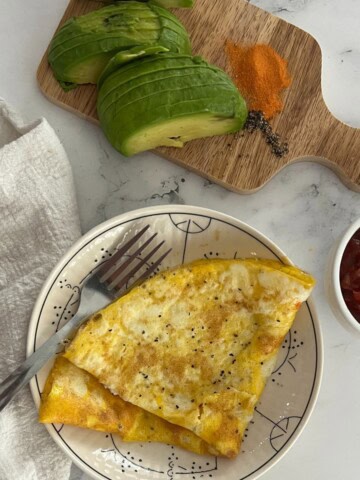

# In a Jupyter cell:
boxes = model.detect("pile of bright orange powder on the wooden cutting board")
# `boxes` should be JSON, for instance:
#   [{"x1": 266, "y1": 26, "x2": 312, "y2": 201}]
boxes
[{"x1": 225, "y1": 40, "x2": 291, "y2": 119}]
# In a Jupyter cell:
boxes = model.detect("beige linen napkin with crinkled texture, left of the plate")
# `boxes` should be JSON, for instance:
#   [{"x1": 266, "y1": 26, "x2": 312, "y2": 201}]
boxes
[{"x1": 0, "y1": 98, "x2": 80, "y2": 480}]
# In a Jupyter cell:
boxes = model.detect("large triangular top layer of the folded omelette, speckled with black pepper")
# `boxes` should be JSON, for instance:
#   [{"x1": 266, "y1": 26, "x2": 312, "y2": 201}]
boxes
[{"x1": 60, "y1": 259, "x2": 314, "y2": 458}]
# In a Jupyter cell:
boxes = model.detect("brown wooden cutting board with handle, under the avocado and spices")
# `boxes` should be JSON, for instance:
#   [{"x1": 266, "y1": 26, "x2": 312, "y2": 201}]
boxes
[{"x1": 37, "y1": 0, "x2": 360, "y2": 193}]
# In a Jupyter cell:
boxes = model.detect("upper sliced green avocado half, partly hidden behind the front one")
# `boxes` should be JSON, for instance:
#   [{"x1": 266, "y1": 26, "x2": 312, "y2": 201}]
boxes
[{"x1": 48, "y1": 1, "x2": 191, "y2": 84}]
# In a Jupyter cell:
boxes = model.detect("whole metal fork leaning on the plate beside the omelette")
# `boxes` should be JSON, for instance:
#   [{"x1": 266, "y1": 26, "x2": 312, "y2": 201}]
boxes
[{"x1": 0, "y1": 225, "x2": 171, "y2": 411}]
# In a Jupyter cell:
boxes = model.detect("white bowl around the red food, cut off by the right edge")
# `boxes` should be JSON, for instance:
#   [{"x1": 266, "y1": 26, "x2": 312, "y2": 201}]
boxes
[{"x1": 325, "y1": 218, "x2": 360, "y2": 335}]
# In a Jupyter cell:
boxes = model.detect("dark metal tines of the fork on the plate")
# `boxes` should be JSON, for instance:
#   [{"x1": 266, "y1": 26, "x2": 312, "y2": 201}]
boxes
[{"x1": 98, "y1": 225, "x2": 171, "y2": 290}]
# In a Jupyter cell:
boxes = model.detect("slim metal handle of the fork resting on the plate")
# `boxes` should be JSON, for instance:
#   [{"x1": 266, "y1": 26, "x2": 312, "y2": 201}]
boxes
[{"x1": 0, "y1": 315, "x2": 86, "y2": 412}]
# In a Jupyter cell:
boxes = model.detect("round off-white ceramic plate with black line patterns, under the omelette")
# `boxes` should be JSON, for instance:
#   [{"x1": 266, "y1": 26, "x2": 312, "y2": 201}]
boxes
[{"x1": 27, "y1": 206, "x2": 323, "y2": 480}]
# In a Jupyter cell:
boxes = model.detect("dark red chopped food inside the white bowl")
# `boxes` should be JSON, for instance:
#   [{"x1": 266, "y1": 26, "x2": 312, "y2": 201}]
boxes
[{"x1": 340, "y1": 229, "x2": 360, "y2": 322}]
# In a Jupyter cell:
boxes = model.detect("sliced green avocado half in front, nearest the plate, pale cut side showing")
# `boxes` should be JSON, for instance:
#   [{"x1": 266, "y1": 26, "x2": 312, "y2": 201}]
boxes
[{"x1": 97, "y1": 53, "x2": 247, "y2": 156}]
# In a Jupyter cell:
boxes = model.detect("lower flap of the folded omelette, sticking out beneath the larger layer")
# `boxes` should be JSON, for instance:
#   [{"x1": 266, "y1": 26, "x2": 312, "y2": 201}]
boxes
[{"x1": 39, "y1": 356, "x2": 216, "y2": 454}]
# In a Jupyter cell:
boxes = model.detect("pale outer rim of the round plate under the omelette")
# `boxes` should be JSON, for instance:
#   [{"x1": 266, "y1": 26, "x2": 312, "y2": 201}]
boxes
[{"x1": 26, "y1": 204, "x2": 324, "y2": 480}]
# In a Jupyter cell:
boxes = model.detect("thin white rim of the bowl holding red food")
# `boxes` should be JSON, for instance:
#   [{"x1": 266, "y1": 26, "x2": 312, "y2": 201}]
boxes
[{"x1": 332, "y1": 218, "x2": 360, "y2": 333}]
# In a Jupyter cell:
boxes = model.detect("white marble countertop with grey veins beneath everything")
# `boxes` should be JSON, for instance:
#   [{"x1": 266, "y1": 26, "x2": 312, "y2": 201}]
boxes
[{"x1": 0, "y1": 0, "x2": 360, "y2": 480}]
